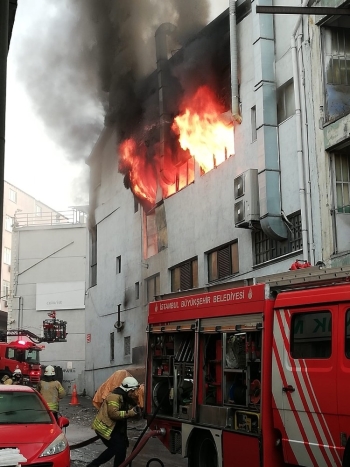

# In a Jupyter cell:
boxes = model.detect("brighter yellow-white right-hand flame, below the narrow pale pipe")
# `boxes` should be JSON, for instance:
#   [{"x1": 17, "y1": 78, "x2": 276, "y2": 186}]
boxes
[{"x1": 172, "y1": 86, "x2": 234, "y2": 172}]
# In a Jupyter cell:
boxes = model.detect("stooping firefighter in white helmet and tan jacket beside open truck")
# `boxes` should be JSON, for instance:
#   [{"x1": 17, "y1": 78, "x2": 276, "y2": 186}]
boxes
[{"x1": 86, "y1": 376, "x2": 141, "y2": 467}]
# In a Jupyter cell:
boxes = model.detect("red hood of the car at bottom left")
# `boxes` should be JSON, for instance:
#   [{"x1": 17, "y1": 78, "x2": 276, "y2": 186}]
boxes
[{"x1": 0, "y1": 424, "x2": 62, "y2": 462}]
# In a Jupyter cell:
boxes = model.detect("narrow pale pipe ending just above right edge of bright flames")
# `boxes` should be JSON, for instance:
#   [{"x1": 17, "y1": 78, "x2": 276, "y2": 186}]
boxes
[{"x1": 229, "y1": 0, "x2": 242, "y2": 123}]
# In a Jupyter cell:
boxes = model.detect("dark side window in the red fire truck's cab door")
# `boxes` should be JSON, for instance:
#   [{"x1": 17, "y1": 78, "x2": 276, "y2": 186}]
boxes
[{"x1": 290, "y1": 311, "x2": 332, "y2": 359}]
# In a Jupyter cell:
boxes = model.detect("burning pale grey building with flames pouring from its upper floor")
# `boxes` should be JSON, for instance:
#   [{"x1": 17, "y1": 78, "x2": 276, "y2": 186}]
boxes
[{"x1": 86, "y1": 0, "x2": 350, "y2": 394}]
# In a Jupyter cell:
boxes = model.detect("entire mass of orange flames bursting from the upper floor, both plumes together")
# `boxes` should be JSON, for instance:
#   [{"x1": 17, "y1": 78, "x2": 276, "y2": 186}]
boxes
[{"x1": 119, "y1": 86, "x2": 234, "y2": 206}]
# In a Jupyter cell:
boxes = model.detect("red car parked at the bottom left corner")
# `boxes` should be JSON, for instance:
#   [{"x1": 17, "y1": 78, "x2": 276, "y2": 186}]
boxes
[{"x1": 0, "y1": 385, "x2": 70, "y2": 467}]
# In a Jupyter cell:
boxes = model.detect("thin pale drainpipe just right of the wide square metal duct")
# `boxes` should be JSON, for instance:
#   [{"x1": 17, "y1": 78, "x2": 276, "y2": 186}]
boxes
[{"x1": 291, "y1": 0, "x2": 315, "y2": 263}]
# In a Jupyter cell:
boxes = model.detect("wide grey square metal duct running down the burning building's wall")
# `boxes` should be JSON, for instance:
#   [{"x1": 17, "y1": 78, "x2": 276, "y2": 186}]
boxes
[{"x1": 252, "y1": 0, "x2": 287, "y2": 240}]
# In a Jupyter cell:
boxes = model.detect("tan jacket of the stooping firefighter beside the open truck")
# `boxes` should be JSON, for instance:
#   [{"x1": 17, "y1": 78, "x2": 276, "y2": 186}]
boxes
[{"x1": 91, "y1": 388, "x2": 137, "y2": 439}]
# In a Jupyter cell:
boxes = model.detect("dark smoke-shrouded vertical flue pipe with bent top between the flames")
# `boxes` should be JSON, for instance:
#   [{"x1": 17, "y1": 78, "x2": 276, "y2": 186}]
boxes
[{"x1": 155, "y1": 23, "x2": 176, "y2": 202}]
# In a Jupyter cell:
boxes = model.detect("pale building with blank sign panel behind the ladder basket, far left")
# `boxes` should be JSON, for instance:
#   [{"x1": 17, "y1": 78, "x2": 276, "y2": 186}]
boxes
[{"x1": 8, "y1": 210, "x2": 87, "y2": 392}]
